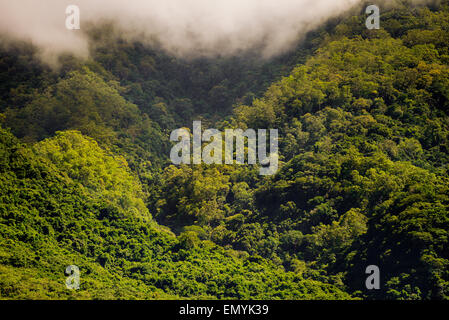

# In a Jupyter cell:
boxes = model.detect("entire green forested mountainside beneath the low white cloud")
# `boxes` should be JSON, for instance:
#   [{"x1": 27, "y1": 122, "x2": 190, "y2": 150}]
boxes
[{"x1": 0, "y1": 1, "x2": 449, "y2": 299}]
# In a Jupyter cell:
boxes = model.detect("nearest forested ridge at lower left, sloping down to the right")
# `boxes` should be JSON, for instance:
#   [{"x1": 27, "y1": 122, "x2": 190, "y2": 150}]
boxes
[{"x1": 0, "y1": 129, "x2": 349, "y2": 299}]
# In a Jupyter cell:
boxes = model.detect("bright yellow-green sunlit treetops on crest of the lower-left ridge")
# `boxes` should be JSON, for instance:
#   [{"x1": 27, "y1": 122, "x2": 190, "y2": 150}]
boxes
[{"x1": 34, "y1": 131, "x2": 151, "y2": 219}]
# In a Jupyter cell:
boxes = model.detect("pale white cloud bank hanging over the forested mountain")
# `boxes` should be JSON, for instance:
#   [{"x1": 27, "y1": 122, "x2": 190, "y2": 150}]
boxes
[{"x1": 0, "y1": 0, "x2": 432, "y2": 63}]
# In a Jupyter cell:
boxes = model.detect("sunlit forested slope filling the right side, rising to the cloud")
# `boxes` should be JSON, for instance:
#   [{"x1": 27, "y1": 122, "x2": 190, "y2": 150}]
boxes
[{"x1": 152, "y1": 1, "x2": 449, "y2": 299}]
